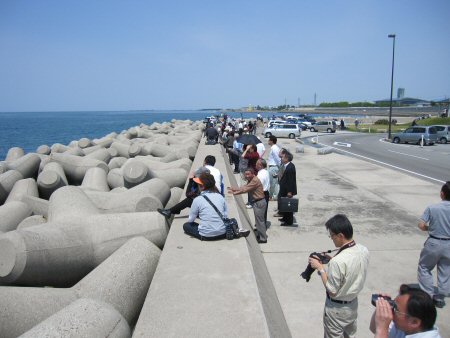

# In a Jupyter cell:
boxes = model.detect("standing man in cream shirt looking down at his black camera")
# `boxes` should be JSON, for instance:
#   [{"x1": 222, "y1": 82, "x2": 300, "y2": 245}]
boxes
[{"x1": 309, "y1": 214, "x2": 369, "y2": 338}]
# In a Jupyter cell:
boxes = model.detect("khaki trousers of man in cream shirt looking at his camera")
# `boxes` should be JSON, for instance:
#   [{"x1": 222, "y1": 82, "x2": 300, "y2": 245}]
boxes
[{"x1": 323, "y1": 298, "x2": 358, "y2": 338}]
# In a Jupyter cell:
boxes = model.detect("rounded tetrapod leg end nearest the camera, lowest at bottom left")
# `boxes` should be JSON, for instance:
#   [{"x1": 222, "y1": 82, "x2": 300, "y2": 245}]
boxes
[{"x1": 20, "y1": 299, "x2": 131, "y2": 338}]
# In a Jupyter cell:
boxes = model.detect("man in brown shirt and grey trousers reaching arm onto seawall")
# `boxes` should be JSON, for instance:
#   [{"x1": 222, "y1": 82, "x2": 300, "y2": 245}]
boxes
[{"x1": 228, "y1": 168, "x2": 267, "y2": 243}]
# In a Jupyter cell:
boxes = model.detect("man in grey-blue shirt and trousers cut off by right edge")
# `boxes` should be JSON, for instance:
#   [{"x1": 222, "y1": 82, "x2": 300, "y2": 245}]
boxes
[{"x1": 417, "y1": 181, "x2": 450, "y2": 308}]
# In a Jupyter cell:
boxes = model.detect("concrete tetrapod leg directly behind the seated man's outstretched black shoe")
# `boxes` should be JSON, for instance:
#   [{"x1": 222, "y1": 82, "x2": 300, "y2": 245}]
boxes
[{"x1": 85, "y1": 178, "x2": 171, "y2": 213}]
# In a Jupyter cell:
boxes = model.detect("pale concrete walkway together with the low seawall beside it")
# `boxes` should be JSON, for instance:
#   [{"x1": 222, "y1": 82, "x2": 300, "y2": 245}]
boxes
[{"x1": 134, "y1": 132, "x2": 450, "y2": 338}]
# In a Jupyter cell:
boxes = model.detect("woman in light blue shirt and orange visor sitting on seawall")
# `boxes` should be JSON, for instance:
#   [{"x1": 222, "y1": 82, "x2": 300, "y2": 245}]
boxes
[{"x1": 183, "y1": 173, "x2": 228, "y2": 241}]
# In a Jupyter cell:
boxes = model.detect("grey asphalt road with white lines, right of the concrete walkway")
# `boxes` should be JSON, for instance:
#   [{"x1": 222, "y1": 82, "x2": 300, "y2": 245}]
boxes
[{"x1": 302, "y1": 131, "x2": 450, "y2": 183}]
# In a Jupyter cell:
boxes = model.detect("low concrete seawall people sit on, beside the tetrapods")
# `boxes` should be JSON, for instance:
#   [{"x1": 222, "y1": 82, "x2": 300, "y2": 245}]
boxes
[{"x1": 133, "y1": 142, "x2": 291, "y2": 337}]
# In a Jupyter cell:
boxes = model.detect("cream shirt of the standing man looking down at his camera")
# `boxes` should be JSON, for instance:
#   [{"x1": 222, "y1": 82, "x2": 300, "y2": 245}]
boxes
[{"x1": 326, "y1": 244, "x2": 369, "y2": 302}]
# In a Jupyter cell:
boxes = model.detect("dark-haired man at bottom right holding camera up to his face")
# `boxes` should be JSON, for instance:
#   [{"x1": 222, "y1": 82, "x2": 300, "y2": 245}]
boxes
[{"x1": 370, "y1": 284, "x2": 441, "y2": 338}]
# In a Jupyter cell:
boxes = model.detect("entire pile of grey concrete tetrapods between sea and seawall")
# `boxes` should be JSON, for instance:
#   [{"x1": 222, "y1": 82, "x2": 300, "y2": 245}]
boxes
[{"x1": 0, "y1": 120, "x2": 203, "y2": 337}]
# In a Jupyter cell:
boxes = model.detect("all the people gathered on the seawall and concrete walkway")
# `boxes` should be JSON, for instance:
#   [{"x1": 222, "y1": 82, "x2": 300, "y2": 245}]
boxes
[{"x1": 158, "y1": 120, "x2": 450, "y2": 338}]
